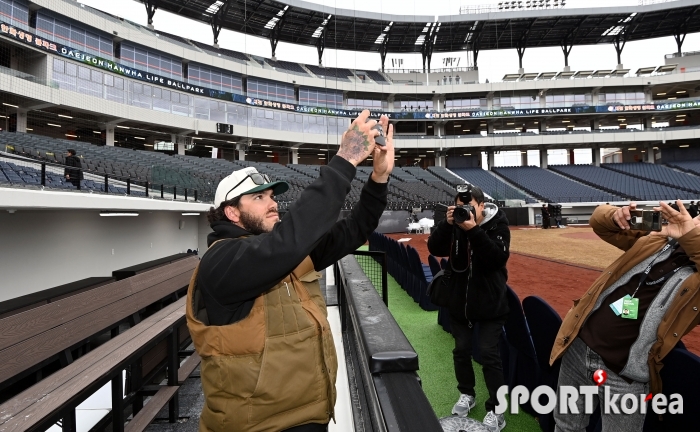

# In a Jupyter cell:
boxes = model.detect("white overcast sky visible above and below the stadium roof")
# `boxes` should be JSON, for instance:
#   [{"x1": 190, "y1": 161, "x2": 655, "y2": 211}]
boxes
[{"x1": 79, "y1": 0, "x2": 700, "y2": 82}]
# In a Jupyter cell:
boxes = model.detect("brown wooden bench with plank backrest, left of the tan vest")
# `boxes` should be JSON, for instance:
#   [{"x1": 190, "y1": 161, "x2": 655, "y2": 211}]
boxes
[{"x1": 0, "y1": 255, "x2": 199, "y2": 432}]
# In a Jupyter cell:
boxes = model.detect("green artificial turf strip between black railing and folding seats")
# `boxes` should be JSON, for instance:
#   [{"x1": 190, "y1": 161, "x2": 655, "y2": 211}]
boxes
[{"x1": 360, "y1": 246, "x2": 541, "y2": 432}]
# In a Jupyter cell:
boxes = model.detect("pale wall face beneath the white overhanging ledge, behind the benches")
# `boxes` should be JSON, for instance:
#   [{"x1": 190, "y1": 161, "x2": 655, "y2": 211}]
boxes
[{"x1": 0, "y1": 210, "x2": 205, "y2": 301}]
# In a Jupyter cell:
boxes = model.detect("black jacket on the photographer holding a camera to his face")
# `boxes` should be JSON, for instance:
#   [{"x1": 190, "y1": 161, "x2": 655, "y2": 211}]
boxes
[{"x1": 428, "y1": 208, "x2": 510, "y2": 322}]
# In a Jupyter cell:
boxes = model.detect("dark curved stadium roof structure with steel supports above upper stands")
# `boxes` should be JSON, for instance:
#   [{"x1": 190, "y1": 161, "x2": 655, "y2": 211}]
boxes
[{"x1": 140, "y1": 0, "x2": 700, "y2": 69}]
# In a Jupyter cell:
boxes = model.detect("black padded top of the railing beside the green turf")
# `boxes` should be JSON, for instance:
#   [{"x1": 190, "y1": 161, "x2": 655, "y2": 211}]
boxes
[{"x1": 341, "y1": 255, "x2": 418, "y2": 374}]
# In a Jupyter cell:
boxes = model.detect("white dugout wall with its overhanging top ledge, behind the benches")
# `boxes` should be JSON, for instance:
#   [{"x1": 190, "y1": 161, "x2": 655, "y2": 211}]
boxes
[{"x1": 0, "y1": 188, "x2": 210, "y2": 301}]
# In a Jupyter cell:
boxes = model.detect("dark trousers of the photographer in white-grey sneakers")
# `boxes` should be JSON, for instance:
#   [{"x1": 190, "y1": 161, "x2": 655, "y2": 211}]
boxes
[{"x1": 450, "y1": 316, "x2": 505, "y2": 412}]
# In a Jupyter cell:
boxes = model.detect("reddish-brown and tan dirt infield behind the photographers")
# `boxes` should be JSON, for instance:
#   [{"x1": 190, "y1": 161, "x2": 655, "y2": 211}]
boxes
[{"x1": 382, "y1": 227, "x2": 700, "y2": 354}]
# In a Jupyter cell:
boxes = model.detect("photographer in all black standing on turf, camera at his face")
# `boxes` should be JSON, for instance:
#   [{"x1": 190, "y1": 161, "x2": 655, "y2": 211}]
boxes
[{"x1": 428, "y1": 185, "x2": 510, "y2": 432}]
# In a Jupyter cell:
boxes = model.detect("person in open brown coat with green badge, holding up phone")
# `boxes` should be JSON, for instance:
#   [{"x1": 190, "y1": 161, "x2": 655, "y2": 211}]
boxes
[{"x1": 549, "y1": 200, "x2": 700, "y2": 432}]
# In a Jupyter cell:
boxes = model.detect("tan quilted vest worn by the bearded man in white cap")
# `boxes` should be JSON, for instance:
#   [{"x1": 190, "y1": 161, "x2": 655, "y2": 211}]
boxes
[{"x1": 187, "y1": 253, "x2": 338, "y2": 432}]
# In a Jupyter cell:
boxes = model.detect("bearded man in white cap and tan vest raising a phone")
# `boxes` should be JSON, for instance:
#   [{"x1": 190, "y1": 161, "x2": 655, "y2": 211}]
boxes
[{"x1": 187, "y1": 110, "x2": 394, "y2": 432}]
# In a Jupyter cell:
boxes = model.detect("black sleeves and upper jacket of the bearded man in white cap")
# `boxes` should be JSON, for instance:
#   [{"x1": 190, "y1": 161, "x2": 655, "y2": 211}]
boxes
[{"x1": 197, "y1": 157, "x2": 387, "y2": 325}]
